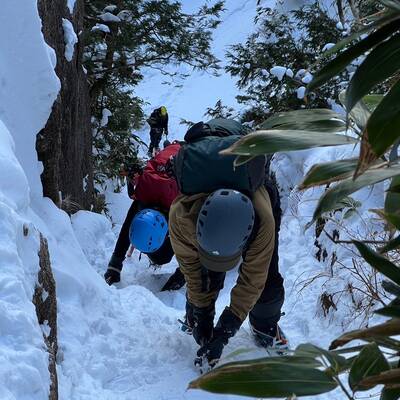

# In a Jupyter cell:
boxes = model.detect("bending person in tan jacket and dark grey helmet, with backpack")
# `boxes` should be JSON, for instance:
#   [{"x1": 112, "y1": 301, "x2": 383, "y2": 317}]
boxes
[{"x1": 169, "y1": 119, "x2": 287, "y2": 367}]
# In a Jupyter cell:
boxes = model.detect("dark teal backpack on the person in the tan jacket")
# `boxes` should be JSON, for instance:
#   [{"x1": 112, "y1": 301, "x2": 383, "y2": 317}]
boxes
[{"x1": 173, "y1": 118, "x2": 266, "y2": 195}]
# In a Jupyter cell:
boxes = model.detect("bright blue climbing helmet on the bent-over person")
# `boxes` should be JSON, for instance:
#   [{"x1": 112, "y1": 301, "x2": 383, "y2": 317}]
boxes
[{"x1": 129, "y1": 208, "x2": 168, "y2": 253}]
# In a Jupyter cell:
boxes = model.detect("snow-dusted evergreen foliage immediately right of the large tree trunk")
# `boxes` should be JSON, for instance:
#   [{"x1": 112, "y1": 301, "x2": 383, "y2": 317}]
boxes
[{"x1": 82, "y1": 0, "x2": 223, "y2": 183}]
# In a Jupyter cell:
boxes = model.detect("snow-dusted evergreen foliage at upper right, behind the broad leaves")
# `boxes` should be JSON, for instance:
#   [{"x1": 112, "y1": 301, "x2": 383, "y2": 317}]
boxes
[{"x1": 226, "y1": 1, "x2": 348, "y2": 123}]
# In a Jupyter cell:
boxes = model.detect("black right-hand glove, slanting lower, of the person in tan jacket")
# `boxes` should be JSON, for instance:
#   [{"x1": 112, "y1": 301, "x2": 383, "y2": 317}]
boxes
[{"x1": 197, "y1": 308, "x2": 242, "y2": 368}]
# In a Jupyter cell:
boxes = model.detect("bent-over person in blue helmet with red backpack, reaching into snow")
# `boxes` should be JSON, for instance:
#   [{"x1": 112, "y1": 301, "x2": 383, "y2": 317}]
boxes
[{"x1": 104, "y1": 143, "x2": 185, "y2": 291}]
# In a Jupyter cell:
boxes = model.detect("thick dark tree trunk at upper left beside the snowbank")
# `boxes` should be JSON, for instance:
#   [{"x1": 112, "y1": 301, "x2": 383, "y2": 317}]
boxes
[{"x1": 36, "y1": 0, "x2": 93, "y2": 212}]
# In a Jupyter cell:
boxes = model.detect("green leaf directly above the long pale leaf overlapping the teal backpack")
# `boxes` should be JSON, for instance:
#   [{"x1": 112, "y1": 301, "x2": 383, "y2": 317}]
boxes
[{"x1": 257, "y1": 108, "x2": 346, "y2": 130}]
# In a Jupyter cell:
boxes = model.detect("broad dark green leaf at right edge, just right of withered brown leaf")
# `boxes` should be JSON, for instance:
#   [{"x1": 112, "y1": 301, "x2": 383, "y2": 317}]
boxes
[{"x1": 366, "y1": 80, "x2": 400, "y2": 157}]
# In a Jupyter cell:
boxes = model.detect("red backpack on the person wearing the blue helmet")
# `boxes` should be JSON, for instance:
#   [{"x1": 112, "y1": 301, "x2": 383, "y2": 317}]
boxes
[{"x1": 135, "y1": 143, "x2": 181, "y2": 211}]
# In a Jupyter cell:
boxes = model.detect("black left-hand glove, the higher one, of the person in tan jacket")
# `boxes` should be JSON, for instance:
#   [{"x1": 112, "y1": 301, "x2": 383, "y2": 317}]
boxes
[{"x1": 186, "y1": 301, "x2": 215, "y2": 346}]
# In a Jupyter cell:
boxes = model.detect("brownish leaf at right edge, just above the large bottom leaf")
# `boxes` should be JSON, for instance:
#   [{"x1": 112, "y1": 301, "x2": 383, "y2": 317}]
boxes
[{"x1": 329, "y1": 319, "x2": 400, "y2": 350}]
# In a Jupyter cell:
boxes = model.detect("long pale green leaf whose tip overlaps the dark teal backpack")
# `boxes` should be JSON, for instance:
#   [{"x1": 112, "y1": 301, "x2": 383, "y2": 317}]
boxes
[{"x1": 221, "y1": 130, "x2": 355, "y2": 161}]
